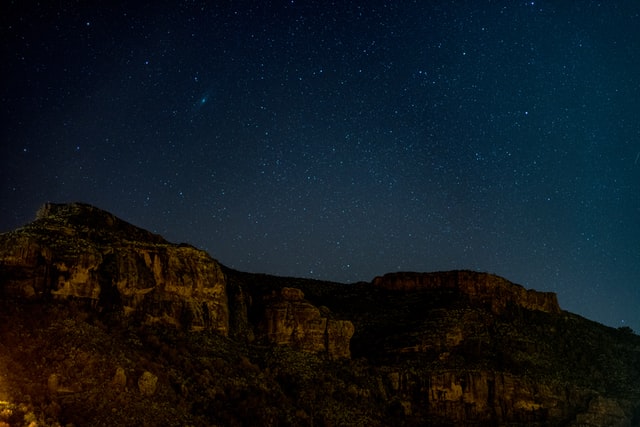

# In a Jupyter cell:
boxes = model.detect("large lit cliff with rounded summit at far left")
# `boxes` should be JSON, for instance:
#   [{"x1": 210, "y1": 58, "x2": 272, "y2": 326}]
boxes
[{"x1": 0, "y1": 203, "x2": 229, "y2": 335}]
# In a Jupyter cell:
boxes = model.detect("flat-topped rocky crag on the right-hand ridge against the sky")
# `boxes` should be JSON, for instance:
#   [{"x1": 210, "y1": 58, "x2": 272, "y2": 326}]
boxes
[{"x1": 372, "y1": 271, "x2": 560, "y2": 313}]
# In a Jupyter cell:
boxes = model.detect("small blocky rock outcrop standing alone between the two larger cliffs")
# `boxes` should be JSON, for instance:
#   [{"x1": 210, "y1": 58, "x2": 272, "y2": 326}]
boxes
[{"x1": 264, "y1": 288, "x2": 354, "y2": 358}]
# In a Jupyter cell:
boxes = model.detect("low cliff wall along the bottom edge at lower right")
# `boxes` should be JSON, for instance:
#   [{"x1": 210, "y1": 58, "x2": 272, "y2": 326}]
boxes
[{"x1": 386, "y1": 370, "x2": 596, "y2": 425}]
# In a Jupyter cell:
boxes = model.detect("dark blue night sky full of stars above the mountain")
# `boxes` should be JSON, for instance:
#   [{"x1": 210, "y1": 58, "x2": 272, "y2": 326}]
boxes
[{"x1": 0, "y1": 0, "x2": 640, "y2": 333}]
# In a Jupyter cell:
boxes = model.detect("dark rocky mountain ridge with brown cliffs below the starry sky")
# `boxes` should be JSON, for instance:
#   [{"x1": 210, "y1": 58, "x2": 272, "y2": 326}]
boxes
[{"x1": 0, "y1": 203, "x2": 640, "y2": 427}]
